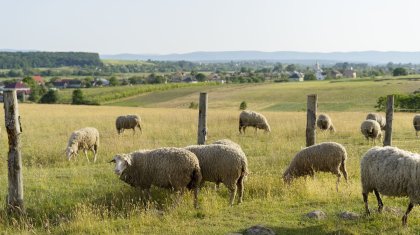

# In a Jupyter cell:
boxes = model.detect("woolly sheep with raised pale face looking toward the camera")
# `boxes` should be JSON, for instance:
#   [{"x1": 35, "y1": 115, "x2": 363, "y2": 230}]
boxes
[{"x1": 110, "y1": 147, "x2": 202, "y2": 208}]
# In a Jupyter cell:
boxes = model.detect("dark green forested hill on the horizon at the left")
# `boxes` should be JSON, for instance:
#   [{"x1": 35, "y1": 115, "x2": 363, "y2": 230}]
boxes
[{"x1": 0, "y1": 51, "x2": 102, "y2": 69}]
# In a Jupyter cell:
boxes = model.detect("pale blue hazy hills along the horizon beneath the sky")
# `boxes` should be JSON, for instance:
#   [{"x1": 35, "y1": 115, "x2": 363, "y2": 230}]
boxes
[{"x1": 101, "y1": 51, "x2": 420, "y2": 64}]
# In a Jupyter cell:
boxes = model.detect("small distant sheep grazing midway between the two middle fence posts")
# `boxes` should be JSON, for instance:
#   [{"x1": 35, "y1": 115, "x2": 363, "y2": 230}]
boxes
[{"x1": 239, "y1": 110, "x2": 271, "y2": 134}]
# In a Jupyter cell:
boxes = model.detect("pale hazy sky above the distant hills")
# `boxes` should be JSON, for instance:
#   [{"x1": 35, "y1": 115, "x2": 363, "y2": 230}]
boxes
[{"x1": 0, "y1": 0, "x2": 420, "y2": 54}]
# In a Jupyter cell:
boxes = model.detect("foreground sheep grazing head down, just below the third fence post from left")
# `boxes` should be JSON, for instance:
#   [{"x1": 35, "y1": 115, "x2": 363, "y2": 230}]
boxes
[{"x1": 283, "y1": 142, "x2": 347, "y2": 191}]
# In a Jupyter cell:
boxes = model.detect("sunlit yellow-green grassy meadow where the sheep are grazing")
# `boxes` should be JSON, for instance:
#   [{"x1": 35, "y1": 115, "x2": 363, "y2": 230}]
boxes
[{"x1": 0, "y1": 80, "x2": 420, "y2": 234}]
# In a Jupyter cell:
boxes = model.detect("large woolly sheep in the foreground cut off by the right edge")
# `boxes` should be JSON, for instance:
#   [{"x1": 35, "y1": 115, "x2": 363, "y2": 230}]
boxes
[{"x1": 360, "y1": 146, "x2": 420, "y2": 226}]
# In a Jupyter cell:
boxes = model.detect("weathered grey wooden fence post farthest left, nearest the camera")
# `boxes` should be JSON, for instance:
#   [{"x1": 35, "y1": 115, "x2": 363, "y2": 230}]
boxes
[{"x1": 3, "y1": 90, "x2": 25, "y2": 214}]
